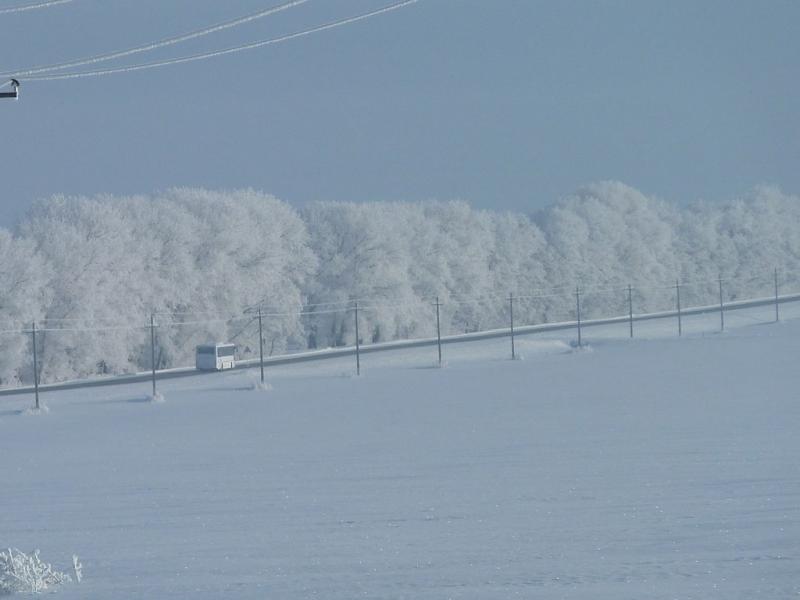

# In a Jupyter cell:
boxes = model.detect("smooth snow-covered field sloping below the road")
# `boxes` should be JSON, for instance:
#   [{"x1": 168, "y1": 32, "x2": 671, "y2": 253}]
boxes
[{"x1": 0, "y1": 306, "x2": 800, "y2": 600}]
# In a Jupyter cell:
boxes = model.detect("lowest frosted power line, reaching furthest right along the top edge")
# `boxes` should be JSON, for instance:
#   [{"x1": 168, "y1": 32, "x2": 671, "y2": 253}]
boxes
[{"x1": 20, "y1": 0, "x2": 418, "y2": 81}]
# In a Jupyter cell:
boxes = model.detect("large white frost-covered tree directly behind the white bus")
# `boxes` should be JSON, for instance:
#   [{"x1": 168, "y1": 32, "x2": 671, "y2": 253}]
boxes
[{"x1": 129, "y1": 189, "x2": 316, "y2": 365}]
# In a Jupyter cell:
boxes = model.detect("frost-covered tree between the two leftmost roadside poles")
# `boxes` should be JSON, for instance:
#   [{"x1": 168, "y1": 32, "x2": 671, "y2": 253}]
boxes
[{"x1": 21, "y1": 196, "x2": 141, "y2": 380}]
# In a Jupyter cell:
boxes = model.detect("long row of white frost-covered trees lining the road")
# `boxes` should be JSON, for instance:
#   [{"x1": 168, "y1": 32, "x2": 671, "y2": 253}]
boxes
[{"x1": 0, "y1": 182, "x2": 800, "y2": 385}]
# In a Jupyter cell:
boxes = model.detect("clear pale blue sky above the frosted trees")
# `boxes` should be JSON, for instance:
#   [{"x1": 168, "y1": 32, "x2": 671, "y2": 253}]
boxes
[{"x1": 0, "y1": 0, "x2": 800, "y2": 225}]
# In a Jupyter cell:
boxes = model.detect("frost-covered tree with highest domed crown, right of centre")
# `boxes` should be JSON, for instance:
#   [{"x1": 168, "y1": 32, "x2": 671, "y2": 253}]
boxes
[{"x1": 538, "y1": 182, "x2": 681, "y2": 320}]
